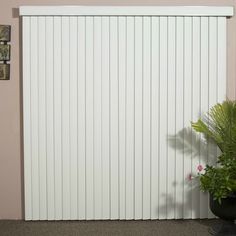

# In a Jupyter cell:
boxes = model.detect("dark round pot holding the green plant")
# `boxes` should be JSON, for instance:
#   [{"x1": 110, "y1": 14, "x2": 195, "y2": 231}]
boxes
[{"x1": 210, "y1": 194, "x2": 236, "y2": 221}]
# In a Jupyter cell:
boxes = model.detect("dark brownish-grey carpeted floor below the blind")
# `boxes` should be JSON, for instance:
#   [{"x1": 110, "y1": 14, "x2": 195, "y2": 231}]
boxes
[{"x1": 0, "y1": 220, "x2": 236, "y2": 236}]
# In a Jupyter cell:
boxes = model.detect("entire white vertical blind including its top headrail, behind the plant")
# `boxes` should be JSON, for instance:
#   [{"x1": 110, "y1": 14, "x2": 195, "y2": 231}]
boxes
[{"x1": 21, "y1": 6, "x2": 232, "y2": 220}]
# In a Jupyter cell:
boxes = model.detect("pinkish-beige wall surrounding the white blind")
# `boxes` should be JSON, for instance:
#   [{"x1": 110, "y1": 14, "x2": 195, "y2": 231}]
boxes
[{"x1": 0, "y1": 0, "x2": 236, "y2": 219}]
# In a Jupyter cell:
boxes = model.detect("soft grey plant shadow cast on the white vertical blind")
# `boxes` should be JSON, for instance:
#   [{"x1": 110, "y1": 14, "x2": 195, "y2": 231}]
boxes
[{"x1": 159, "y1": 127, "x2": 217, "y2": 218}]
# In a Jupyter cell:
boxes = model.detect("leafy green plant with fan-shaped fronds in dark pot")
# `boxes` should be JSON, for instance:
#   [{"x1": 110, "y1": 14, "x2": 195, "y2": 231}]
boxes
[{"x1": 191, "y1": 100, "x2": 236, "y2": 202}]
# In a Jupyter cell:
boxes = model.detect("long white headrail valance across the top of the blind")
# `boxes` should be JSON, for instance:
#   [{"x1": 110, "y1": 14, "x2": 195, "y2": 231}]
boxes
[{"x1": 20, "y1": 6, "x2": 234, "y2": 17}]
